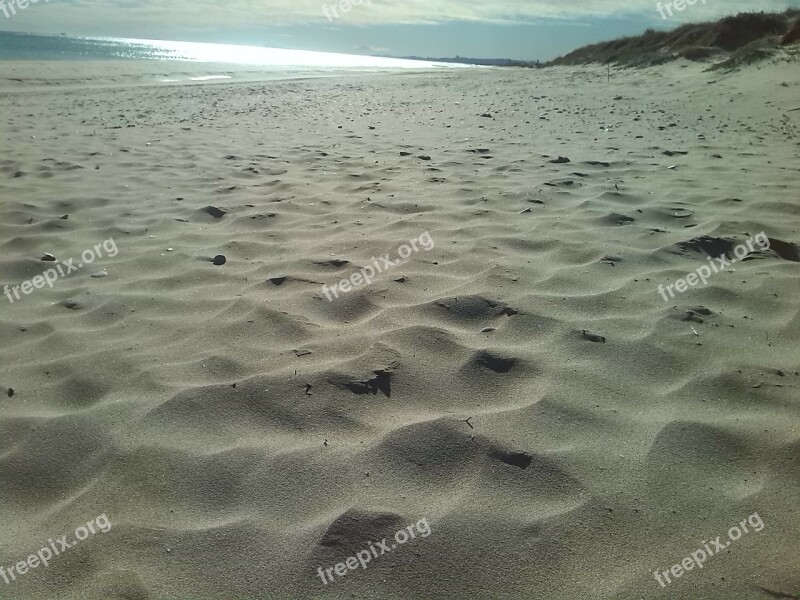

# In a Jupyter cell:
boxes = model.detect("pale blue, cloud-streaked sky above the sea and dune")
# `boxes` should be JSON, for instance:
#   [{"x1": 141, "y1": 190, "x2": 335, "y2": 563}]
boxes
[{"x1": 0, "y1": 0, "x2": 800, "y2": 60}]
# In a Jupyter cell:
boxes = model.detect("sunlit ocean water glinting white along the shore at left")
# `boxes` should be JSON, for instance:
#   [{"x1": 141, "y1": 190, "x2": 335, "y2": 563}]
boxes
[{"x1": 0, "y1": 31, "x2": 450, "y2": 69}]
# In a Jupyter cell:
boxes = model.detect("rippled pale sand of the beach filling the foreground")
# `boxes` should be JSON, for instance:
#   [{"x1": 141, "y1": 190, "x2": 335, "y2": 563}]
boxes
[{"x1": 0, "y1": 57, "x2": 800, "y2": 600}]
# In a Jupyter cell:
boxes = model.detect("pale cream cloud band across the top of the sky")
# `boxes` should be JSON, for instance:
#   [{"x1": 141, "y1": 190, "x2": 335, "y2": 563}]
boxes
[{"x1": 10, "y1": 0, "x2": 800, "y2": 31}]
